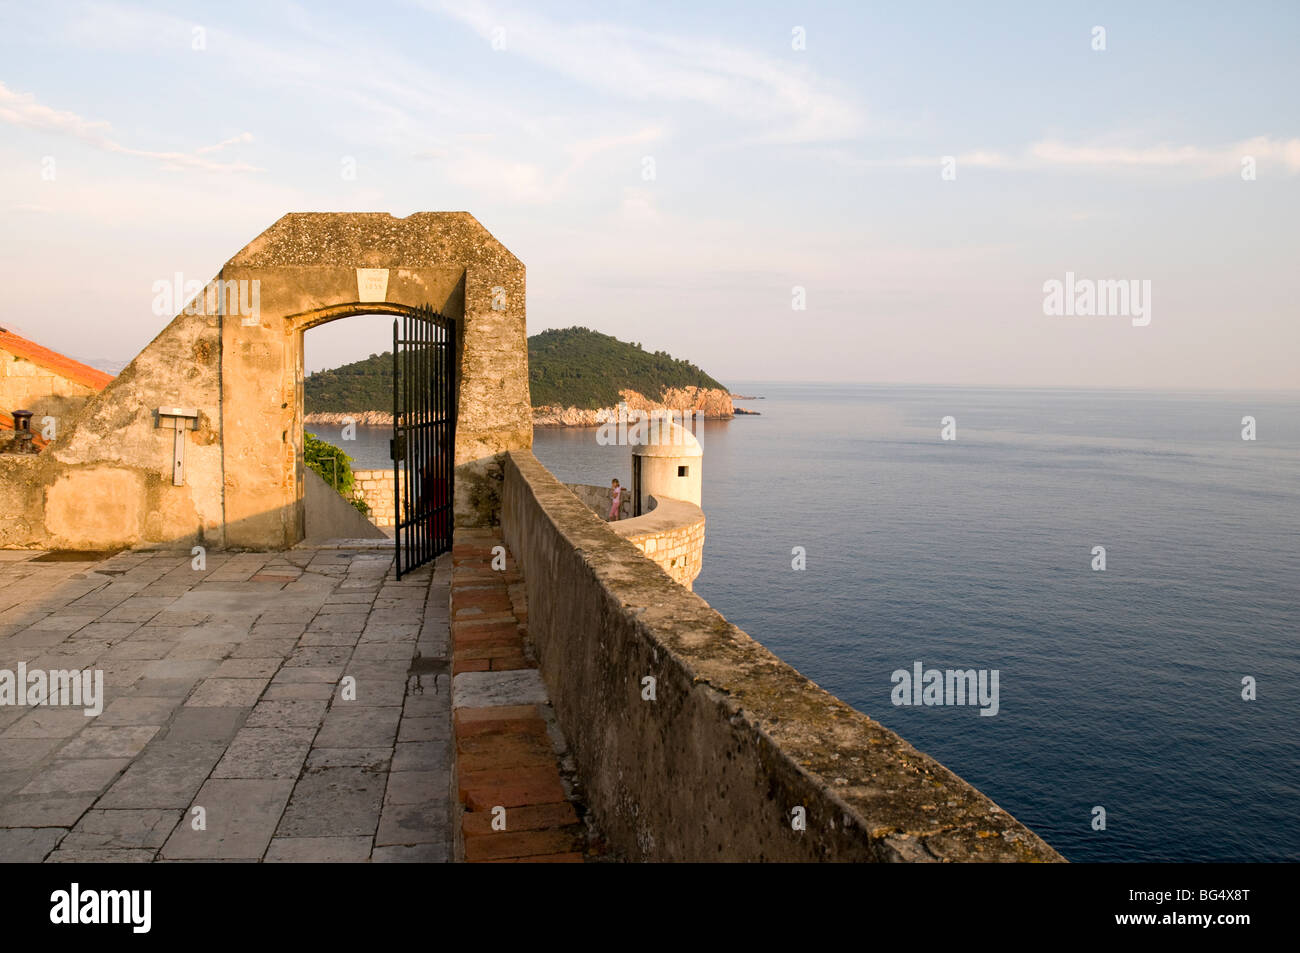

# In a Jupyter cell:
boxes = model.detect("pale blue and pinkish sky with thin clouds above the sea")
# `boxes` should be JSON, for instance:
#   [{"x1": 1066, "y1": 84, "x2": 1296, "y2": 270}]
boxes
[{"x1": 0, "y1": 0, "x2": 1300, "y2": 390}]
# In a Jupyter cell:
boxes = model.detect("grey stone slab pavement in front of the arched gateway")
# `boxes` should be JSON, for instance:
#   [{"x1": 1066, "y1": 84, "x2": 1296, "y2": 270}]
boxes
[{"x1": 0, "y1": 545, "x2": 452, "y2": 862}]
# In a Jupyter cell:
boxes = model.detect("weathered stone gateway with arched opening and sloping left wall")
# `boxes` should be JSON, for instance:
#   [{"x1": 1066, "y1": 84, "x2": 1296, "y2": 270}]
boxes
[{"x1": 0, "y1": 212, "x2": 532, "y2": 550}]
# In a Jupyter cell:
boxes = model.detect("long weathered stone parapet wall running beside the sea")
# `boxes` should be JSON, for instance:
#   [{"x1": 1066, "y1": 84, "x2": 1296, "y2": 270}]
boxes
[{"x1": 502, "y1": 451, "x2": 1063, "y2": 862}]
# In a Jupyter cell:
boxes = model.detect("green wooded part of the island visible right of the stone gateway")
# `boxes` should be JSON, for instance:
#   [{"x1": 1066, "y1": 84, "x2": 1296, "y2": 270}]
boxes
[{"x1": 528, "y1": 328, "x2": 725, "y2": 410}]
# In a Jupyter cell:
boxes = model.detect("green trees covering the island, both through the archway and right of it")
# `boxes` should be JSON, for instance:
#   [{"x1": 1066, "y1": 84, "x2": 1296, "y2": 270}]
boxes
[{"x1": 303, "y1": 328, "x2": 725, "y2": 410}]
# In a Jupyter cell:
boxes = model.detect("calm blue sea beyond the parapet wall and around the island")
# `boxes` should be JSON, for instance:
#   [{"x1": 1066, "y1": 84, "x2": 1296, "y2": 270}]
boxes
[{"x1": 306, "y1": 381, "x2": 1300, "y2": 862}]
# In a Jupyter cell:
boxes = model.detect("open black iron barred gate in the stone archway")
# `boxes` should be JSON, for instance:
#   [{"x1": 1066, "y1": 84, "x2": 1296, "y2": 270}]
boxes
[{"x1": 390, "y1": 306, "x2": 456, "y2": 579}]
